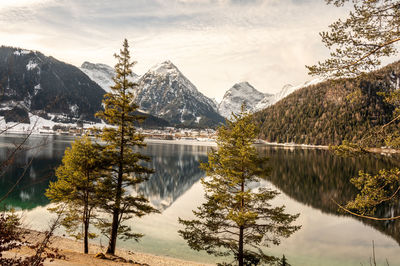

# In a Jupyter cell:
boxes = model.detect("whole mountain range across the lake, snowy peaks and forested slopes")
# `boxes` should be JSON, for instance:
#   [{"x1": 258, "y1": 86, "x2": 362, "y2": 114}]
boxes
[{"x1": 6, "y1": 46, "x2": 400, "y2": 145}]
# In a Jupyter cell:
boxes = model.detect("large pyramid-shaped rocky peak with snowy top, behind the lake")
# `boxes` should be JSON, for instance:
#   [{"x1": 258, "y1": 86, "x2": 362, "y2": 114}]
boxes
[{"x1": 136, "y1": 61, "x2": 224, "y2": 127}]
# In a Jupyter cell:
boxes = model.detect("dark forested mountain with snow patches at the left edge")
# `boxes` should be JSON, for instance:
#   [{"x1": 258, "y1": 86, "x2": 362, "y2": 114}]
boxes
[{"x1": 0, "y1": 46, "x2": 105, "y2": 122}]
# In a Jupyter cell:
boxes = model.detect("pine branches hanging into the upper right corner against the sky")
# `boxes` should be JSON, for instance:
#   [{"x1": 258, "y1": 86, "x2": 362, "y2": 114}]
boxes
[{"x1": 307, "y1": 0, "x2": 400, "y2": 77}]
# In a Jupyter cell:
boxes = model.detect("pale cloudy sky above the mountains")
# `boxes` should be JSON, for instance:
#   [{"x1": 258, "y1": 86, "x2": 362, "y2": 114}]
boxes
[{"x1": 0, "y1": 0, "x2": 354, "y2": 99}]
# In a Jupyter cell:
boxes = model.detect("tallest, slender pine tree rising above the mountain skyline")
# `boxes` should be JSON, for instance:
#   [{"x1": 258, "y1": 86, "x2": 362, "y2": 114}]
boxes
[{"x1": 96, "y1": 39, "x2": 156, "y2": 254}]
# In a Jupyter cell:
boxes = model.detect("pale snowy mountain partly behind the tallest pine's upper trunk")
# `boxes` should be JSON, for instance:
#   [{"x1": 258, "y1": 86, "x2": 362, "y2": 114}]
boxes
[{"x1": 80, "y1": 61, "x2": 139, "y2": 92}]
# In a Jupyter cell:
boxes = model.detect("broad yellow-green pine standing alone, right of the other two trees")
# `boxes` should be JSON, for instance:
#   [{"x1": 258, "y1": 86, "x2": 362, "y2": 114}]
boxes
[{"x1": 179, "y1": 106, "x2": 300, "y2": 265}]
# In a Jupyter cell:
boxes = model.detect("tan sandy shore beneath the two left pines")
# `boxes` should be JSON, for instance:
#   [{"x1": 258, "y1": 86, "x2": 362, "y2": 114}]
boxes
[{"x1": 5, "y1": 230, "x2": 212, "y2": 266}]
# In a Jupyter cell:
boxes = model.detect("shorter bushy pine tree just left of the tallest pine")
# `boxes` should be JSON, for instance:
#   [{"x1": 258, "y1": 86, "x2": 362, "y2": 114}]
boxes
[{"x1": 46, "y1": 137, "x2": 101, "y2": 254}]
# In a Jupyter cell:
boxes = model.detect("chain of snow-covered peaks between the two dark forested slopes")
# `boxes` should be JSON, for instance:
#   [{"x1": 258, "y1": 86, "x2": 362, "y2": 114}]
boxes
[{"x1": 82, "y1": 60, "x2": 323, "y2": 120}]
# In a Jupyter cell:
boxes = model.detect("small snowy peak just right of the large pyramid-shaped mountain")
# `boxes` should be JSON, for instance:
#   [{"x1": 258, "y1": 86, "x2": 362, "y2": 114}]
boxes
[{"x1": 218, "y1": 82, "x2": 272, "y2": 117}]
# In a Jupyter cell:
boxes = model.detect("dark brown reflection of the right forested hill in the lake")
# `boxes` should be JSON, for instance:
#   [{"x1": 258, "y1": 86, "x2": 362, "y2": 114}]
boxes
[{"x1": 260, "y1": 148, "x2": 400, "y2": 245}]
